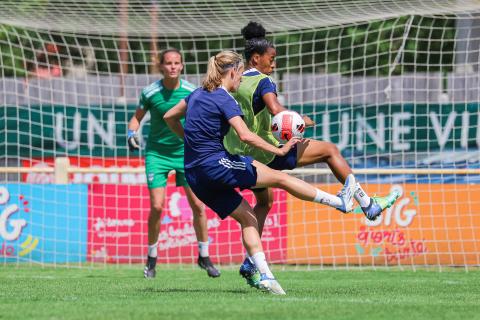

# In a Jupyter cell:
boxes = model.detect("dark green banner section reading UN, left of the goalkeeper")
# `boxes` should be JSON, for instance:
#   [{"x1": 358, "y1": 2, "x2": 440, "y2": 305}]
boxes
[{"x1": 1, "y1": 105, "x2": 142, "y2": 157}]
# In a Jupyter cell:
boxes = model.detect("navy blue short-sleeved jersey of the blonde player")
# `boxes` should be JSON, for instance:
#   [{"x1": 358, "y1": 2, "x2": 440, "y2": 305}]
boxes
[{"x1": 184, "y1": 88, "x2": 243, "y2": 168}]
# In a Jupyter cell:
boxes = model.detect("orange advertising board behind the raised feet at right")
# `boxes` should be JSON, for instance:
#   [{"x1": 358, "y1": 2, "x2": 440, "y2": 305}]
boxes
[{"x1": 287, "y1": 184, "x2": 480, "y2": 266}]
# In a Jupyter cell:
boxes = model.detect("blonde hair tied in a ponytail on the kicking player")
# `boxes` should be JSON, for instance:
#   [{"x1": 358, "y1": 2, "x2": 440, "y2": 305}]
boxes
[{"x1": 202, "y1": 51, "x2": 243, "y2": 91}]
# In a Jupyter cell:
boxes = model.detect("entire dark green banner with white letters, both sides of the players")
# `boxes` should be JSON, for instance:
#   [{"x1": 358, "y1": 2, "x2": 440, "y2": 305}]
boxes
[{"x1": 0, "y1": 103, "x2": 480, "y2": 157}]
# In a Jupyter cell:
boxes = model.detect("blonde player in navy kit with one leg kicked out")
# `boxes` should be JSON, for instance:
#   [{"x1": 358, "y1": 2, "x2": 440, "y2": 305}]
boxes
[{"x1": 164, "y1": 51, "x2": 355, "y2": 294}]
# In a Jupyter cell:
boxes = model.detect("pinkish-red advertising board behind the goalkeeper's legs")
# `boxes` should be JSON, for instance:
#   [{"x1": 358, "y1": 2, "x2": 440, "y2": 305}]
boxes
[{"x1": 87, "y1": 176, "x2": 287, "y2": 263}]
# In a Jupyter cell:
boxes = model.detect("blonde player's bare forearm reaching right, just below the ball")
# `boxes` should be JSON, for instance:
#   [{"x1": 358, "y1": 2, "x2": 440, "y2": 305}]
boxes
[{"x1": 228, "y1": 116, "x2": 299, "y2": 156}]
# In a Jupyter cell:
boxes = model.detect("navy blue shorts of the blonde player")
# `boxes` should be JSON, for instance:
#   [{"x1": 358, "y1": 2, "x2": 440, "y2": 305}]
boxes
[{"x1": 185, "y1": 154, "x2": 257, "y2": 219}]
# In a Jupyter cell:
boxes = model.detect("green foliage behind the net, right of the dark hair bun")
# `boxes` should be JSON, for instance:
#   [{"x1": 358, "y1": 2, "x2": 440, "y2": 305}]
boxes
[{"x1": 274, "y1": 17, "x2": 455, "y2": 76}]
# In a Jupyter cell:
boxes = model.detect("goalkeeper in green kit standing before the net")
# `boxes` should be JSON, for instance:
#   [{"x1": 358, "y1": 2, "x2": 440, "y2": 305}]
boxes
[{"x1": 128, "y1": 49, "x2": 220, "y2": 278}]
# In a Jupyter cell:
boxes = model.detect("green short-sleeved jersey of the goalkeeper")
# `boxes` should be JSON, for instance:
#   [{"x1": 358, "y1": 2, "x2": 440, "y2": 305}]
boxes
[{"x1": 139, "y1": 80, "x2": 195, "y2": 152}]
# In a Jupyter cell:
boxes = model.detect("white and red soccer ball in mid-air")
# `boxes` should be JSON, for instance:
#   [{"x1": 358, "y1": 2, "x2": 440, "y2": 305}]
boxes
[{"x1": 272, "y1": 110, "x2": 305, "y2": 143}]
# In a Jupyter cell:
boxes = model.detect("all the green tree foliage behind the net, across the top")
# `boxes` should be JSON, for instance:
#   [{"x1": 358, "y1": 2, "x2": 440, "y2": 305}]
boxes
[{"x1": 0, "y1": 17, "x2": 455, "y2": 76}]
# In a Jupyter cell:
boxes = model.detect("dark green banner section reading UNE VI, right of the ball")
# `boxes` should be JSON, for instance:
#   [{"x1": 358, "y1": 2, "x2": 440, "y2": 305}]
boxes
[{"x1": 291, "y1": 103, "x2": 480, "y2": 154}]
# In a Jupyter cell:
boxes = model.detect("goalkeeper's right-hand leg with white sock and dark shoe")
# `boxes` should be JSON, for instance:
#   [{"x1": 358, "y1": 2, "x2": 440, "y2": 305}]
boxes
[{"x1": 184, "y1": 187, "x2": 220, "y2": 278}]
